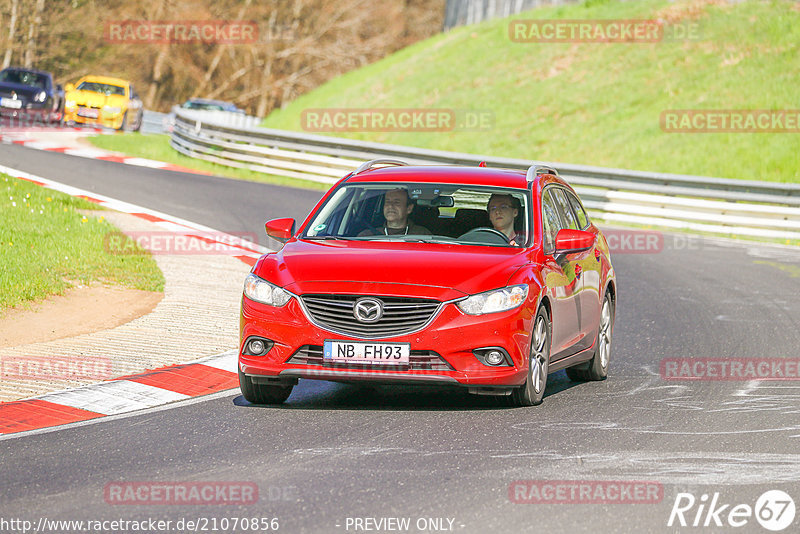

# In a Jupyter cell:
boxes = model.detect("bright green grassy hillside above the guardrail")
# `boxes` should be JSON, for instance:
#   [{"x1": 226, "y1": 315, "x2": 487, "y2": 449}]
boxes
[{"x1": 264, "y1": 0, "x2": 800, "y2": 182}]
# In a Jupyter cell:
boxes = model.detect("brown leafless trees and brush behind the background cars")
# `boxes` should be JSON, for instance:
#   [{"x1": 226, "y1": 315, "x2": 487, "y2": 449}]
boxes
[{"x1": 0, "y1": 0, "x2": 445, "y2": 116}]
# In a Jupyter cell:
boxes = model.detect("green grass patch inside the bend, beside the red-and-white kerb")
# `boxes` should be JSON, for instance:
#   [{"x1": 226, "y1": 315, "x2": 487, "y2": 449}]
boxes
[{"x1": 0, "y1": 174, "x2": 164, "y2": 314}]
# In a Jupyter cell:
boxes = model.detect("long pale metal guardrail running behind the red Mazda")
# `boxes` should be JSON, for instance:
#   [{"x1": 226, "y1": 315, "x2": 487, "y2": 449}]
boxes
[{"x1": 170, "y1": 111, "x2": 800, "y2": 240}]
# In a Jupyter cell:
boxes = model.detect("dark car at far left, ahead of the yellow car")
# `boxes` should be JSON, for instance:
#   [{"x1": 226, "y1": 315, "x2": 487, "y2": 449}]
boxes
[{"x1": 0, "y1": 67, "x2": 64, "y2": 122}]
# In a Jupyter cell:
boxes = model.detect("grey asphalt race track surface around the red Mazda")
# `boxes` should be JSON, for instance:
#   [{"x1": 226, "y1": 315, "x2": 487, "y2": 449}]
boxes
[{"x1": 0, "y1": 145, "x2": 800, "y2": 533}]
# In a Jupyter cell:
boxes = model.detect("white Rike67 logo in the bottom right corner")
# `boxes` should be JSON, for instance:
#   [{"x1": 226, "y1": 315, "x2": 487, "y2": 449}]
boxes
[{"x1": 667, "y1": 490, "x2": 796, "y2": 532}]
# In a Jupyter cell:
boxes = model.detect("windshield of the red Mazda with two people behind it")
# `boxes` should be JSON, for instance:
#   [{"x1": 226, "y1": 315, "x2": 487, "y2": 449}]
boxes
[{"x1": 303, "y1": 182, "x2": 532, "y2": 247}]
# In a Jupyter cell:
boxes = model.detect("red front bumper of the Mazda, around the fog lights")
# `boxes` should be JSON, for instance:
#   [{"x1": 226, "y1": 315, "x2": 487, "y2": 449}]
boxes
[{"x1": 239, "y1": 297, "x2": 536, "y2": 388}]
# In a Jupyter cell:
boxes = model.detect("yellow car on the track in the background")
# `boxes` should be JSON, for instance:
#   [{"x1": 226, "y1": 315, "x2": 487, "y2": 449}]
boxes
[{"x1": 64, "y1": 76, "x2": 144, "y2": 132}]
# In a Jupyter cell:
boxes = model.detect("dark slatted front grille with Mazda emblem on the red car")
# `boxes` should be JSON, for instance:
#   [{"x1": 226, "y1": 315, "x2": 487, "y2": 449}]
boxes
[{"x1": 301, "y1": 295, "x2": 441, "y2": 338}]
